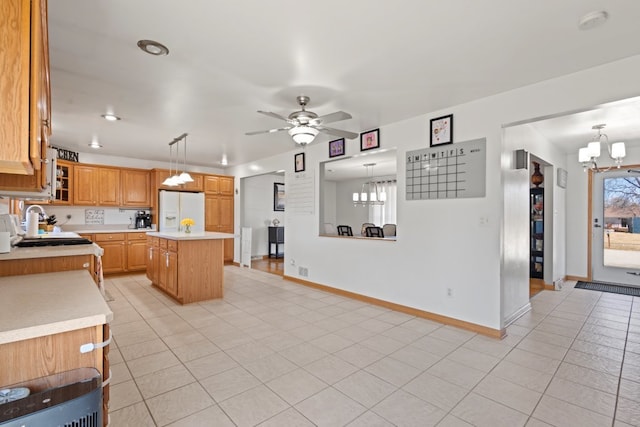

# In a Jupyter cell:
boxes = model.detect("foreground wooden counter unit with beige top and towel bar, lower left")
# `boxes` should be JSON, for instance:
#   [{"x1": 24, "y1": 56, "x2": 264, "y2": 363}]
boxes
[{"x1": 0, "y1": 270, "x2": 113, "y2": 420}]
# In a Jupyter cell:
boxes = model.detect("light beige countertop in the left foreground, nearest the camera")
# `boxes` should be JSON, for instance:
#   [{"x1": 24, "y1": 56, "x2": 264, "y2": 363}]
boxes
[{"x1": 0, "y1": 270, "x2": 113, "y2": 344}]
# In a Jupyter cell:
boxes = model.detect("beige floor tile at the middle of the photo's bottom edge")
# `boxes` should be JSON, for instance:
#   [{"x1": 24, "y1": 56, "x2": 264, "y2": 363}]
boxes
[{"x1": 295, "y1": 387, "x2": 366, "y2": 427}]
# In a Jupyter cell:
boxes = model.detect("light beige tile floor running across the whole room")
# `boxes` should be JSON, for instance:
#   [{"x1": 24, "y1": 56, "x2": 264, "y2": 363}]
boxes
[{"x1": 106, "y1": 266, "x2": 640, "y2": 427}]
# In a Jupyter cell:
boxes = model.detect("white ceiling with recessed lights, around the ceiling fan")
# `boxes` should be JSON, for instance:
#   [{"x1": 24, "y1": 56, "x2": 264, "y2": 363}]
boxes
[{"x1": 49, "y1": 0, "x2": 640, "y2": 168}]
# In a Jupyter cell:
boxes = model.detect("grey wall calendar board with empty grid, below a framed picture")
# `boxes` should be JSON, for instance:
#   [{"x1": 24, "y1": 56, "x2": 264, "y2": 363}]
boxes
[{"x1": 406, "y1": 138, "x2": 487, "y2": 200}]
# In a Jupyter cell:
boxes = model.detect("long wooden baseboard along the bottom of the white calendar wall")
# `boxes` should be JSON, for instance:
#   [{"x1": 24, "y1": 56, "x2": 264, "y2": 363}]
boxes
[{"x1": 283, "y1": 275, "x2": 507, "y2": 339}]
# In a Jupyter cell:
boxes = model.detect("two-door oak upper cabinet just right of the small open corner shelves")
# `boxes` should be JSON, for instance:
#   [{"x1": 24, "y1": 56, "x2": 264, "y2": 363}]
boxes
[{"x1": 73, "y1": 164, "x2": 120, "y2": 206}]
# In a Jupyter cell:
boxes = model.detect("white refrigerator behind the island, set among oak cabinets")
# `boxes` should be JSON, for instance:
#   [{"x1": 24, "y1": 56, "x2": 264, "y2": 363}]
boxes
[{"x1": 159, "y1": 190, "x2": 204, "y2": 232}]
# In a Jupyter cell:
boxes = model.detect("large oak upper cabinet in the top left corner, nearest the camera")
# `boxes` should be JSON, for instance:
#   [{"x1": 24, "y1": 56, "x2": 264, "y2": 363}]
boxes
[{"x1": 0, "y1": 0, "x2": 51, "y2": 176}]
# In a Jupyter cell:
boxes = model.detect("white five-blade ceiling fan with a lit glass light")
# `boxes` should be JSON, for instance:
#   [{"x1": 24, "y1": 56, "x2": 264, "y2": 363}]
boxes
[{"x1": 246, "y1": 95, "x2": 358, "y2": 145}]
